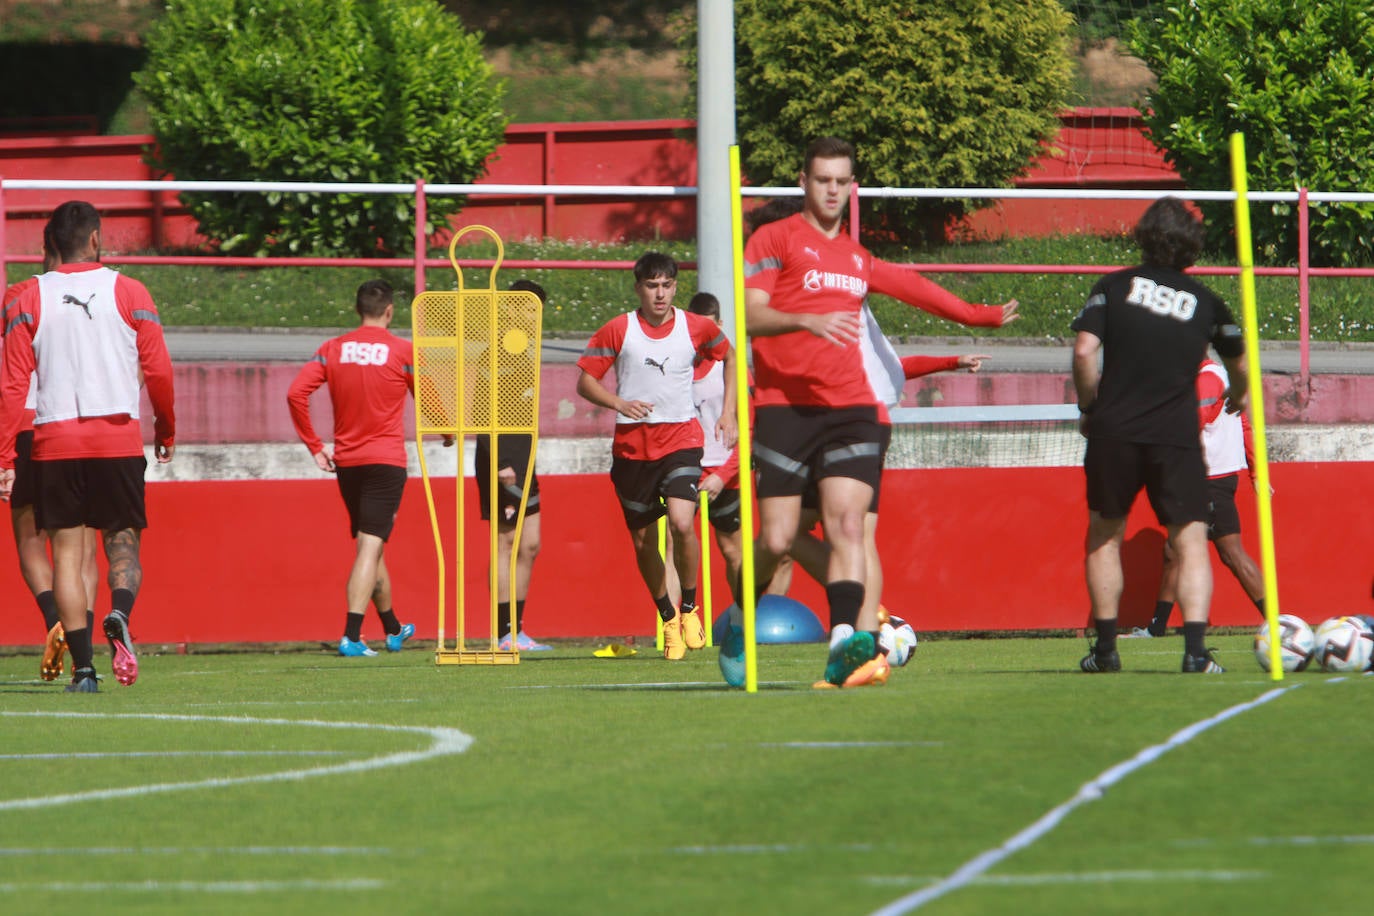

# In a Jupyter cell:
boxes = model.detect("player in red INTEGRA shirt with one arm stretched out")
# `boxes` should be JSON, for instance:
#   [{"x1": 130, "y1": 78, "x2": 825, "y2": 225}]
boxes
[{"x1": 745, "y1": 137, "x2": 1017, "y2": 687}]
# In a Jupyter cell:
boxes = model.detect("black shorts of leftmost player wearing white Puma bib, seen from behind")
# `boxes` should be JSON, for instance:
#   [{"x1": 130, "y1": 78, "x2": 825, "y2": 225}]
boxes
[{"x1": 29, "y1": 455, "x2": 148, "y2": 531}]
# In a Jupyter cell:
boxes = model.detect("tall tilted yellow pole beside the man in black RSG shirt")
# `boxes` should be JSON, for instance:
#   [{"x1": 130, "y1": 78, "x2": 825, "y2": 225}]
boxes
[{"x1": 1231, "y1": 130, "x2": 1283, "y2": 681}]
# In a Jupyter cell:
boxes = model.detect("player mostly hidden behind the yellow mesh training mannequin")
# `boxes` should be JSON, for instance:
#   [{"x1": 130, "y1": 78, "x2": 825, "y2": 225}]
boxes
[{"x1": 473, "y1": 279, "x2": 552, "y2": 652}]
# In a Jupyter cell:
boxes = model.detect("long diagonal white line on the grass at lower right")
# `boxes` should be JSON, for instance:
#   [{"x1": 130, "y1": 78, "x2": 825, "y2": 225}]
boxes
[{"x1": 872, "y1": 684, "x2": 1301, "y2": 916}]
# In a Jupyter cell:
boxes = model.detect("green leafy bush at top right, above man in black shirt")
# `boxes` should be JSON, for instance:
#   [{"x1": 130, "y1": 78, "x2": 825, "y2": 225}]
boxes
[{"x1": 1131, "y1": 0, "x2": 1374, "y2": 266}]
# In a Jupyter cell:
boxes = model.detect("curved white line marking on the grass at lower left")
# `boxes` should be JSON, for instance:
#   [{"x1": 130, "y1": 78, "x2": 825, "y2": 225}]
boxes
[{"x1": 0, "y1": 711, "x2": 473, "y2": 812}]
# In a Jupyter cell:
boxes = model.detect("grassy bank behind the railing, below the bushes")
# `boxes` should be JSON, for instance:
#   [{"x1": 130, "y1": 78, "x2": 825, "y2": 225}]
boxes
[{"x1": 8, "y1": 236, "x2": 1374, "y2": 342}]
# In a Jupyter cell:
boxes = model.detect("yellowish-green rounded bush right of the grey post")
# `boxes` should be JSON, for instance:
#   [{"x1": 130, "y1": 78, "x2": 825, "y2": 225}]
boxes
[{"x1": 688, "y1": 0, "x2": 1073, "y2": 242}]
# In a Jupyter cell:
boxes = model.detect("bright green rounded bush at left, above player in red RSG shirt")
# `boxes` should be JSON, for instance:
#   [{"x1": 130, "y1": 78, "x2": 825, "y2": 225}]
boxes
[{"x1": 137, "y1": 0, "x2": 506, "y2": 255}]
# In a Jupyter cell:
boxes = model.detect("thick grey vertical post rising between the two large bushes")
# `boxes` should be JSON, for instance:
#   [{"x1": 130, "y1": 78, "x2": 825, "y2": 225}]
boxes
[{"x1": 697, "y1": 0, "x2": 736, "y2": 341}]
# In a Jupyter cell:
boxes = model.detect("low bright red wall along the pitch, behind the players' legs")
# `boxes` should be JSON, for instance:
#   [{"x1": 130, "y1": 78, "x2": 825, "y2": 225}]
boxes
[{"x1": 0, "y1": 463, "x2": 1374, "y2": 644}]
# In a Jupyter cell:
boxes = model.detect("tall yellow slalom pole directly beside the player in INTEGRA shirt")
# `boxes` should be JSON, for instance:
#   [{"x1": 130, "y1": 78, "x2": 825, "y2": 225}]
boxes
[{"x1": 730, "y1": 144, "x2": 758, "y2": 694}]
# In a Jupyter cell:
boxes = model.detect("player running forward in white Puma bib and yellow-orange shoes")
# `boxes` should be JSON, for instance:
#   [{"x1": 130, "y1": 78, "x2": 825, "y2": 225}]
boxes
[{"x1": 577, "y1": 251, "x2": 736, "y2": 661}]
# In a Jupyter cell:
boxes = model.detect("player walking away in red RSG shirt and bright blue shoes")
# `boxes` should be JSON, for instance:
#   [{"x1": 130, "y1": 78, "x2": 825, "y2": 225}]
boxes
[{"x1": 286, "y1": 280, "x2": 453, "y2": 658}]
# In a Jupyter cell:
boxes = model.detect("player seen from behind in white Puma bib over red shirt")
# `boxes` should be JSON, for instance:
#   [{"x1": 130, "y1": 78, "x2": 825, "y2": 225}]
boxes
[{"x1": 0, "y1": 201, "x2": 176, "y2": 694}]
